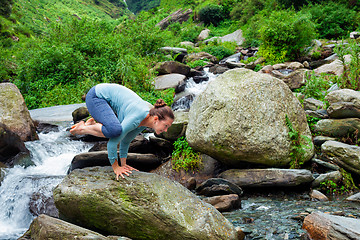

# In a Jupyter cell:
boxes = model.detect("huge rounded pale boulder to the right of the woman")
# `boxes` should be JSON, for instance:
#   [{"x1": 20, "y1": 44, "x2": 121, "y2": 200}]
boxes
[{"x1": 186, "y1": 69, "x2": 314, "y2": 167}]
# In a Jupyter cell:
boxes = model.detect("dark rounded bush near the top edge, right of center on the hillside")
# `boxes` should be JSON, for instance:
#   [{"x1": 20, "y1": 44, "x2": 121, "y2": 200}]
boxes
[{"x1": 199, "y1": 4, "x2": 227, "y2": 26}]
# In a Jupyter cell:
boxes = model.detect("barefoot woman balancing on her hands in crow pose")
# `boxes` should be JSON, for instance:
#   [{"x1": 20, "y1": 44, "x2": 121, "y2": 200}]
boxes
[{"x1": 70, "y1": 83, "x2": 174, "y2": 180}]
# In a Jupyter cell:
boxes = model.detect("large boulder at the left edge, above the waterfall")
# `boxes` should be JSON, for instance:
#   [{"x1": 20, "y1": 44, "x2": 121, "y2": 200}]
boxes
[{"x1": 0, "y1": 83, "x2": 39, "y2": 141}]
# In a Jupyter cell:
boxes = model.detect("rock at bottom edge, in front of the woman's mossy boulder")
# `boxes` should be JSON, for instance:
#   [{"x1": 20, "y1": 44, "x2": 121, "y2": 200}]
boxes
[{"x1": 19, "y1": 214, "x2": 131, "y2": 240}]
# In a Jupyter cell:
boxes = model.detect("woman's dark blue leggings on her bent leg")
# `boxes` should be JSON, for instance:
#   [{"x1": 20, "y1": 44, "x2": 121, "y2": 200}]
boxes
[{"x1": 85, "y1": 87, "x2": 122, "y2": 138}]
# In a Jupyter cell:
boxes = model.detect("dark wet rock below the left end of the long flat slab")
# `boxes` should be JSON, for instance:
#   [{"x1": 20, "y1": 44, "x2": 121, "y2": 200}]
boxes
[{"x1": 196, "y1": 178, "x2": 243, "y2": 197}]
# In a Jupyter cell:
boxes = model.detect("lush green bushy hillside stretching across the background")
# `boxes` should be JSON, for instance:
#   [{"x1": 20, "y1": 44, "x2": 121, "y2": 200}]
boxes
[{"x1": 0, "y1": 0, "x2": 360, "y2": 109}]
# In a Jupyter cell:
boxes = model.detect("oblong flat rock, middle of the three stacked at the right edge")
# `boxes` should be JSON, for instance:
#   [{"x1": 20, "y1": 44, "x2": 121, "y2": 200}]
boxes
[{"x1": 314, "y1": 118, "x2": 360, "y2": 137}]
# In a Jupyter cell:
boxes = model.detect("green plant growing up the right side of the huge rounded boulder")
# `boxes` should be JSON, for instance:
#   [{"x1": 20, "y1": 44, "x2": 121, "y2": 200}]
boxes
[{"x1": 285, "y1": 115, "x2": 312, "y2": 169}]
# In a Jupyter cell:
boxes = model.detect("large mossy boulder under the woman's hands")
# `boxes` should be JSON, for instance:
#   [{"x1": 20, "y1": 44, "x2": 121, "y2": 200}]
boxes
[{"x1": 53, "y1": 167, "x2": 238, "y2": 240}]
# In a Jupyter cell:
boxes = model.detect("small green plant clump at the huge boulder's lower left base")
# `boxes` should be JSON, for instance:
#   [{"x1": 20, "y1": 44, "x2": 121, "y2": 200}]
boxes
[{"x1": 171, "y1": 137, "x2": 202, "y2": 171}]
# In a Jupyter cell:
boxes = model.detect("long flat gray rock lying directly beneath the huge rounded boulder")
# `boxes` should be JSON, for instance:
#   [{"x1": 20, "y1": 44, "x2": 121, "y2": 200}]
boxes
[{"x1": 219, "y1": 168, "x2": 314, "y2": 188}]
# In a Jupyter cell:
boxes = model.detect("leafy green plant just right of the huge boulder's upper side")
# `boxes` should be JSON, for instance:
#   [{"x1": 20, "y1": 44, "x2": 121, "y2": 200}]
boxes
[{"x1": 296, "y1": 71, "x2": 331, "y2": 101}]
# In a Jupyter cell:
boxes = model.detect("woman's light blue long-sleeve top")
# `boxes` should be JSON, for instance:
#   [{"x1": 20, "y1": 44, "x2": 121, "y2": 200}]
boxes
[{"x1": 95, "y1": 83, "x2": 152, "y2": 165}]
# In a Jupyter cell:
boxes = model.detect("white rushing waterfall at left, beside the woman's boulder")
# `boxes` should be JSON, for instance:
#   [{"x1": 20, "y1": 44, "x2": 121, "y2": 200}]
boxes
[{"x1": 0, "y1": 126, "x2": 91, "y2": 240}]
